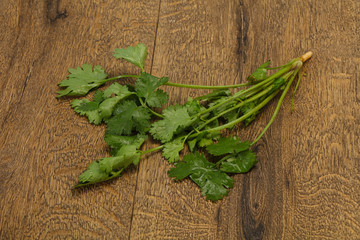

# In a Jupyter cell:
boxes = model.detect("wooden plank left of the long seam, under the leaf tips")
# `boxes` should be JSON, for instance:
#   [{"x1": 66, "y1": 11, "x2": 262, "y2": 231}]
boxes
[{"x1": 0, "y1": 1, "x2": 158, "y2": 239}]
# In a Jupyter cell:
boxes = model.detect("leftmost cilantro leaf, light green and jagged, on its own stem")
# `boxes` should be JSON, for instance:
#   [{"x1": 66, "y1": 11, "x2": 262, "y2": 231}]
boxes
[{"x1": 56, "y1": 63, "x2": 107, "y2": 98}]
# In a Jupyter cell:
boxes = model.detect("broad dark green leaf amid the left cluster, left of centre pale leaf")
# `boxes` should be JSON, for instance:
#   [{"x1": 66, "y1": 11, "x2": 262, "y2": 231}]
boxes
[{"x1": 106, "y1": 101, "x2": 151, "y2": 135}]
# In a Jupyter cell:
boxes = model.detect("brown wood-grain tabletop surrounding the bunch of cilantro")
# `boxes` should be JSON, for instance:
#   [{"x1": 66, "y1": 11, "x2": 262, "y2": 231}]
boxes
[{"x1": 0, "y1": 0, "x2": 360, "y2": 240}]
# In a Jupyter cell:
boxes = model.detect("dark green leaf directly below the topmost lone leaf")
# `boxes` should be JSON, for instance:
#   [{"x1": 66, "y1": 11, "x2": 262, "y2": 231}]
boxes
[{"x1": 135, "y1": 72, "x2": 169, "y2": 107}]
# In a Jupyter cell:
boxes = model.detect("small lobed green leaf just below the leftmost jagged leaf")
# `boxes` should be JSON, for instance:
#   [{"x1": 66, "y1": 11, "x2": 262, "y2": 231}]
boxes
[{"x1": 71, "y1": 91, "x2": 103, "y2": 125}]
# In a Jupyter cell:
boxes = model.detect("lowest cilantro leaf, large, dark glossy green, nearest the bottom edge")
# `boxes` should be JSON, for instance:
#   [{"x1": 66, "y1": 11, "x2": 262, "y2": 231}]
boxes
[{"x1": 168, "y1": 152, "x2": 234, "y2": 201}]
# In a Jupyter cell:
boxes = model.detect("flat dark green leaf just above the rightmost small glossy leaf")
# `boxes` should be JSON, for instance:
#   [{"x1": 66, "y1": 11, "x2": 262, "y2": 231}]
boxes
[{"x1": 206, "y1": 137, "x2": 251, "y2": 156}]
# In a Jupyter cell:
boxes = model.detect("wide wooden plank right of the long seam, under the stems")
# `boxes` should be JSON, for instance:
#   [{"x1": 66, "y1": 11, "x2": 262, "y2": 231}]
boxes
[{"x1": 131, "y1": 1, "x2": 360, "y2": 239}]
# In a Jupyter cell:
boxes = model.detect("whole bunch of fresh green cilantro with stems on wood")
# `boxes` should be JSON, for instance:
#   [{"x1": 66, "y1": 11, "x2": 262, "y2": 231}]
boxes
[{"x1": 57, "y1": 44, "x2": 311, "y2": 201}]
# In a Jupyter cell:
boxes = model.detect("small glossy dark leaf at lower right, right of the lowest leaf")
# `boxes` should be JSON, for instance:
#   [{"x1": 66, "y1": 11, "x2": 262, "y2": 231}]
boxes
[{"x1": 220, "y1": 150, "x2": 257, "y2": 173}]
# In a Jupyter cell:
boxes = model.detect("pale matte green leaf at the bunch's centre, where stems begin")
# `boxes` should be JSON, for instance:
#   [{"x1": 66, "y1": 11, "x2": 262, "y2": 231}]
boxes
[{"x1": 150, "y1": 105, "x2": 192, "y2": 143}]
